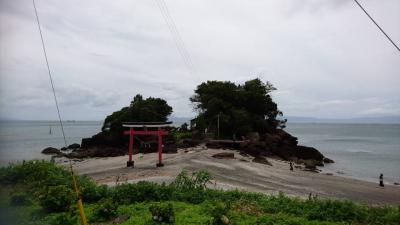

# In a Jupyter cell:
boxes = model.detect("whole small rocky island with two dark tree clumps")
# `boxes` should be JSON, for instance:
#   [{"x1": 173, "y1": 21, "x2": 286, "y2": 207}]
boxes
[{"x1": 43, "y1": 79, "x2": 333, "y2": 170}]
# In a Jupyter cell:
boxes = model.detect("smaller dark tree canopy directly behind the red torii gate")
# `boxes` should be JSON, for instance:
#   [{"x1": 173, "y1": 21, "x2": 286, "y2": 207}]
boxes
[{"x1": 102, "y1": 94, "x2": 172, "y2": 135}]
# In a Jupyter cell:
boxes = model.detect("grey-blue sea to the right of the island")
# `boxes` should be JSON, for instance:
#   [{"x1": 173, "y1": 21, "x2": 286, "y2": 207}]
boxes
[{"x1": 285, "y1": 123, "x2": 400, "y2": 184}]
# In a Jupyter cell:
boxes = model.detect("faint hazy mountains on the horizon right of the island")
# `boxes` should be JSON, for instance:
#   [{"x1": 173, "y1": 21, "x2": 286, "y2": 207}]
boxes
[{"x1": 285, "y1": 116, "x2": 400, "y2": 124}]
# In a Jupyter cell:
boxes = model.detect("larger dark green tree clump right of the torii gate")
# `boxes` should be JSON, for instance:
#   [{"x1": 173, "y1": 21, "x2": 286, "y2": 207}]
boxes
[{"x1": 190, "y1": 78, "x2": 286, "y2": 138}]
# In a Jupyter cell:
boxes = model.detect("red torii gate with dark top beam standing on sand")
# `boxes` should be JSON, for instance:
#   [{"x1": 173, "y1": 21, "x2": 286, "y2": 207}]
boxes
[{"x1": 122, "y1": 122, "x2": 172, "y2": 167}]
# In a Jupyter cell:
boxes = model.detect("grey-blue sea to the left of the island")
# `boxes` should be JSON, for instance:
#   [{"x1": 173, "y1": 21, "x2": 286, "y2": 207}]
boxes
[{"x1": 0, "y1": 121, "x2": 102, "y2": 166}]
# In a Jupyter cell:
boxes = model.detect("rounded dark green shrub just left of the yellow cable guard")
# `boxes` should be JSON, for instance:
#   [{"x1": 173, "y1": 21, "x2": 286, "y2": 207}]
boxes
[{"x1": 39, "y1": 185, "x2": 75, "y2": 212}]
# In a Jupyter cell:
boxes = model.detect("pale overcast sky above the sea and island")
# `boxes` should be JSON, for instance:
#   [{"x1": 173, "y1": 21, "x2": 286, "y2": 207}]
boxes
[{"x1": 0, "y1": 0, "x2": 400, "y2": 120}]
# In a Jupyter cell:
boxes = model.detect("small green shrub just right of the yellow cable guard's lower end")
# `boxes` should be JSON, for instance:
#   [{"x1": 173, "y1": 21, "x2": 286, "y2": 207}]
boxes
[{"x1": 90, "y1": 198, "x2": 118, "y2": 222}]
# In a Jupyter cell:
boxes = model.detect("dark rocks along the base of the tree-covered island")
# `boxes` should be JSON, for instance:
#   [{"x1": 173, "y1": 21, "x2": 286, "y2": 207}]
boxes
[{"x1": 42, "y1": 129, "x2": 333, "y2": 170}]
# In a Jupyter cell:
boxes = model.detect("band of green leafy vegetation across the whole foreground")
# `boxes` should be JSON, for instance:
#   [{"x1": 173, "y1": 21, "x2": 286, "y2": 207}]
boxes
[{"x1": 0, "y1": 161, "x2": 400, "y2": 225}]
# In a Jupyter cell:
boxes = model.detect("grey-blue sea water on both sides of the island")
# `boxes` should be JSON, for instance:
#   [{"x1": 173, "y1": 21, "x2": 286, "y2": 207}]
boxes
[{"x1": 0, "y1": 121, "x2": 400, "y2": 183}]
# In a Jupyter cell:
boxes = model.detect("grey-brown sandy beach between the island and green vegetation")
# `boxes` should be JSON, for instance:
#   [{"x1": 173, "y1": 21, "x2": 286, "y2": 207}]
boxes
[{"x1": 64, "y1": 148, "x2": 400, "y2": 205}]
